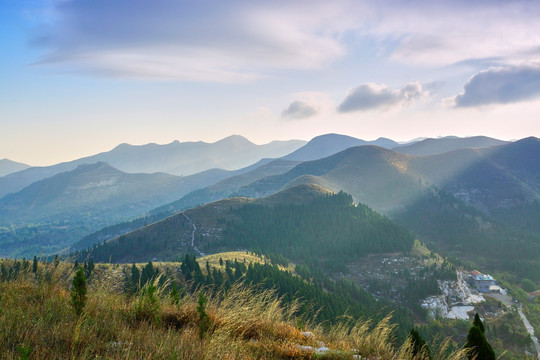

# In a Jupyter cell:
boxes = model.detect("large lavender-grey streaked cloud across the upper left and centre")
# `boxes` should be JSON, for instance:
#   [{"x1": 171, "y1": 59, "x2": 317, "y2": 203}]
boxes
[{"x1": 33, "y1": 0, "x2": 368, "y2": 82}]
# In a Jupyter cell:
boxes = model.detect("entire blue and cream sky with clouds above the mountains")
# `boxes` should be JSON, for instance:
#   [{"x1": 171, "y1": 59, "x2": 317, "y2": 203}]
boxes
[{"x1": 0, "y1": 0, "x2": 540, "y2": 166}]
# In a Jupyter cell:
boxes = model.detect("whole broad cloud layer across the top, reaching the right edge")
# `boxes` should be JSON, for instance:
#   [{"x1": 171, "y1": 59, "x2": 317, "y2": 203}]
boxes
[{"x1": 32, "y1": 0, "x2": 540, "y2": 82}]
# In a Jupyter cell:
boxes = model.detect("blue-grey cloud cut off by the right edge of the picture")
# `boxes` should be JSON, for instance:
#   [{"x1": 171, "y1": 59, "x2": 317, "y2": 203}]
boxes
[{"x1": 455, "y1": 64, "x2": 540, "y2": 107}]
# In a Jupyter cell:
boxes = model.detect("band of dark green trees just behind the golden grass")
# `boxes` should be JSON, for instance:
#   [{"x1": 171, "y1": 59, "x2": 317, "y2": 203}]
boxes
[{"x1": 119, "y1": 255, "x2": 412, "y2": 339}]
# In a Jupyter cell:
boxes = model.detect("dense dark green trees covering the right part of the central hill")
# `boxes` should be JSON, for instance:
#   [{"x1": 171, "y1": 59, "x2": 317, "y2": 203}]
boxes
[{"x1": 219, "y1": 192, "x2": 413, "y2": 267}]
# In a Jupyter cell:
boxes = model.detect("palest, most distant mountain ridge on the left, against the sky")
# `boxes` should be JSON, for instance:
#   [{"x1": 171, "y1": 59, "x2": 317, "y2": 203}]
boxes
[{"x1": 0, "y1": 135, "x2": 306, "y2": 198}]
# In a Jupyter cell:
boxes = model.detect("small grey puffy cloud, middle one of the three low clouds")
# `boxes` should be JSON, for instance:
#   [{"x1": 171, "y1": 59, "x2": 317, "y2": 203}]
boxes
[{"x1": 338, "y1": 83, "x2": 427, "y2": 113}]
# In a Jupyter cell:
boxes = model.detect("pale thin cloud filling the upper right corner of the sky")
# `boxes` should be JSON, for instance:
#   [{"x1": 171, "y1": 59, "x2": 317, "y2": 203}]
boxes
[{"x1": 371, "y1": 0, "x2": 540, "y2": 66}]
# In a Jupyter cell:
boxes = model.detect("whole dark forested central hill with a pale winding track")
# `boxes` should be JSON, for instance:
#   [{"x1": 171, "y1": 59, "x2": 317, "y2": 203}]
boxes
[{"x1": 75, "y1": 185, "x2": 413, "y2": 265}]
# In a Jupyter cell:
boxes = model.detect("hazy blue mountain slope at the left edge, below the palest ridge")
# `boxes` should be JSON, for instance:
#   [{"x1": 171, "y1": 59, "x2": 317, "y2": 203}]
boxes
[{"x1": 0, "y1": 162, "x2": 256, "y2": 256}]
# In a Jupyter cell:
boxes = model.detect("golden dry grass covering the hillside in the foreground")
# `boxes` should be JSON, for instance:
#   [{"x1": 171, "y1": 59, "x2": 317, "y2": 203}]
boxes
[{"x1": 0, "y1": 263, "x2": 467, "y2": 360}]
